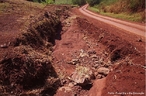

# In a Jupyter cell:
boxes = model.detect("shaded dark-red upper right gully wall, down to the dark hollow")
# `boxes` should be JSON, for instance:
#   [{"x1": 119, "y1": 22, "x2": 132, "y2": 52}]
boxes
[{"x1": 77, "y1": 18, "x2": 138, "y2": 62}]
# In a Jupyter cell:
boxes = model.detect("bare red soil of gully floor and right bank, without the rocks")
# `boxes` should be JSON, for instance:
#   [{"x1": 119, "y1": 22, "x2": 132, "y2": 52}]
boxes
[{"x1": 52, "y1": 9, "x2": 145, "y2": 96}]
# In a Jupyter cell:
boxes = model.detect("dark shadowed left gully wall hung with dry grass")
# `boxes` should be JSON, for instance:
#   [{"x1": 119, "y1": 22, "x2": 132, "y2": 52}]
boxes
[{"x1": 0, "y1": 5, "x2": 68, "y2": 95}]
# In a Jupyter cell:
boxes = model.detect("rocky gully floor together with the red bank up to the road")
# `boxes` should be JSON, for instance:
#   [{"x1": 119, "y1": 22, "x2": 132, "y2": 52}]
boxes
[{"x1": 52, "y1": 9, "x2": 145, "y2": 96}]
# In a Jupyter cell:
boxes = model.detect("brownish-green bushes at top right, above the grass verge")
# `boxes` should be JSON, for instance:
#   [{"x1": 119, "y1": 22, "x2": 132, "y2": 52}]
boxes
[{"x1": 93, "y1": 0, "x2": 145, "y2": 13}]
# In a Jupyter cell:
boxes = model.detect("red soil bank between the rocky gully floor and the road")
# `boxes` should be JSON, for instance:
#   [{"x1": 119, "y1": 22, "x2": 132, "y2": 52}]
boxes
[{"x1": 77, "y1": 18, "x2": 145, "y2": 96}]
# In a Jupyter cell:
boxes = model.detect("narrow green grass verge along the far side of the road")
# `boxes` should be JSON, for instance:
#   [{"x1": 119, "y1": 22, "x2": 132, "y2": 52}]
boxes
[{"x1": 88, "y1": 7, "x2": 143, "y2": 22}]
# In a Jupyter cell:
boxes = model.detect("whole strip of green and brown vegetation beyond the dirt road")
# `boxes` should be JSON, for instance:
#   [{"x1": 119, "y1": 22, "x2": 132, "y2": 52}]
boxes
[{"x1": 28, "y1": 0, "x2": 145, "y2": 22}]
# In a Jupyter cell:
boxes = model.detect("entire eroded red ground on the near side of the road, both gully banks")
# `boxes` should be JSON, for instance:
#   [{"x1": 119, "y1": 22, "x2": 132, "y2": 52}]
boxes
[{"x1": 0, "y1": 0, "x2": 145, "y2": 96}]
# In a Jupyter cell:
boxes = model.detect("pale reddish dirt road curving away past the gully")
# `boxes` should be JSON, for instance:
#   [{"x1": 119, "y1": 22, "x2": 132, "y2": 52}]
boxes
[{"x1": 79, "y1": 4, "x2": 146, "y2": 37}]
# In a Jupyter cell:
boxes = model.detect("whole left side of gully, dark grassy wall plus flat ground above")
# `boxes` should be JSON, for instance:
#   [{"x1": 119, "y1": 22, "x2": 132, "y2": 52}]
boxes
[{"x1": 0, "y1": 0, "x2": 71, "y2": 95}]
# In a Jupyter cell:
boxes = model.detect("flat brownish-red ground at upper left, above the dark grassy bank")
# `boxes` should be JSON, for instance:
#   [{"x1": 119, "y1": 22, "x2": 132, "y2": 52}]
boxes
[{"x1": 0, "y1": 0, "x2": 40, "y2": 59}]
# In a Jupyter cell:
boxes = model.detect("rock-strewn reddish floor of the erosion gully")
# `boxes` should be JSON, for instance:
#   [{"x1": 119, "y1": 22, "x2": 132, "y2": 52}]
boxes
[{"x1": 52, "y1": 15, "x2": 108, "y2": 96}]
